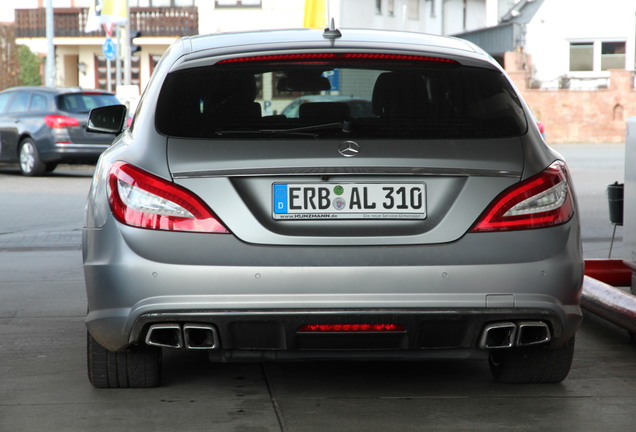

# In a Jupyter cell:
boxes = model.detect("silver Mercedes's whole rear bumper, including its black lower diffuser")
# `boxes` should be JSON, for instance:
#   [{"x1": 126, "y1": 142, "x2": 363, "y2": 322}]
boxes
[{"x1": 84, "y1": 220, "x2": 583, "y2": 352}]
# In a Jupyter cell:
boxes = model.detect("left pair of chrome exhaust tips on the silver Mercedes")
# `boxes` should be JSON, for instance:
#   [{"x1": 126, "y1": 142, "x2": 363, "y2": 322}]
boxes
[{"x1": 145, "y1": 323, "x2": 219, "y2": 350}]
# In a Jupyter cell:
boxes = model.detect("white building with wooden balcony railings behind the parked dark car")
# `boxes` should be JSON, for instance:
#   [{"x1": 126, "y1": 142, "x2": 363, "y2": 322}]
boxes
[{"x1": 9, "y1": 0, "x2": 304, "y2": 97}]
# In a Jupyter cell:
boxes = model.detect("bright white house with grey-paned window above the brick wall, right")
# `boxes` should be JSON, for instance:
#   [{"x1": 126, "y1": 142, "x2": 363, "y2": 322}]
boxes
[{"x1": 524, "y1": 0, "x2": 636, "y2": 88}]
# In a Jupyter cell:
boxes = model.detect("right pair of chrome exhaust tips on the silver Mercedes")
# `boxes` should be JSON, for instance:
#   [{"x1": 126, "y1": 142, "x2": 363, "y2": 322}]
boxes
[{"x1": 479, "y1": 321, "x2": 551, "y2": 349}]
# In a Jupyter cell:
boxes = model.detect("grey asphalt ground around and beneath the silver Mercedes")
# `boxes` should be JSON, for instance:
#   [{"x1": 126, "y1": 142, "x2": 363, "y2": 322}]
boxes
[{"x1": 0, "y1": 146, "x2": 636, "y2": 432}]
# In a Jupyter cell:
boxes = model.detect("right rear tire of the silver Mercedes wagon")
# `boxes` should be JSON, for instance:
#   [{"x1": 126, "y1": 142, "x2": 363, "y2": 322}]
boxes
[{"x1": 488, "y1": 337, "x2": 574, "y2": 384}]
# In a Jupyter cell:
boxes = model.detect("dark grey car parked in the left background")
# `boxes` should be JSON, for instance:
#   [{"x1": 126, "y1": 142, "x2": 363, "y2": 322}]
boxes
[{"x1": 0, "y1": 87, "x2": 119, "y2": 176}]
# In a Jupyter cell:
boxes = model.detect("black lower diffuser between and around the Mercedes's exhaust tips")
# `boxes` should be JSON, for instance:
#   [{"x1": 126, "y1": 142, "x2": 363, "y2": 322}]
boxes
[{"x1": 124, "y1": 306, "x2": 581, "y2": 361}]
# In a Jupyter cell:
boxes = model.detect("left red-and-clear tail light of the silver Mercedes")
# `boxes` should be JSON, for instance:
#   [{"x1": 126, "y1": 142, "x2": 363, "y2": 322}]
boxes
[{"x1": 108, "y1": 162, "x2": 229, "y2": 233}]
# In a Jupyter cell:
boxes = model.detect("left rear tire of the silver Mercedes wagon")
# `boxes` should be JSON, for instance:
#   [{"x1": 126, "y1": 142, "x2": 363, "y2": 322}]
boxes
[{"x1": 86, "y1": 333, "x2": 161, "y2": 388}]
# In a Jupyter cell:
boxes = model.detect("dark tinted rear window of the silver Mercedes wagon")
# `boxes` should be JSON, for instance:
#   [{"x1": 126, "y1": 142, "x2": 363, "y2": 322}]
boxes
[{"x1": 155, "y1": 56, "x2": 527, "y2": 139}]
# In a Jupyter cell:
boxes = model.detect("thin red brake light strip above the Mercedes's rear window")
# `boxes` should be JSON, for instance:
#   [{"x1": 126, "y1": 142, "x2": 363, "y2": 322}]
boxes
[{"x1": 218, "y1": 53, "x2": 457, "y2": 64}]
